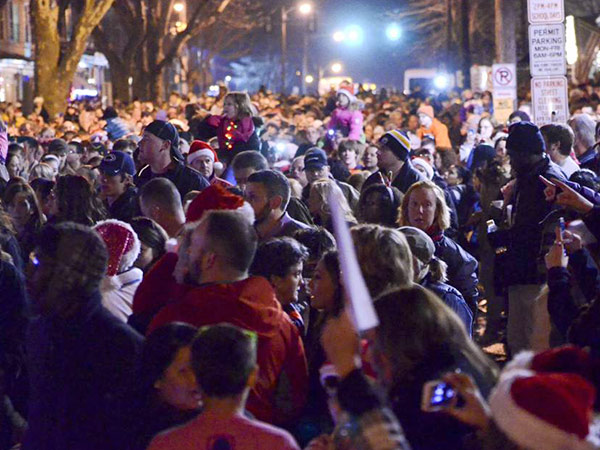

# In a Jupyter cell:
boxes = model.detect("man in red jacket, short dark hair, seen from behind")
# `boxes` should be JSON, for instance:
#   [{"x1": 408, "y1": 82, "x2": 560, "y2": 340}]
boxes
[{"x1": 148, "y1": 211, "x2": 308, "y2": 424}]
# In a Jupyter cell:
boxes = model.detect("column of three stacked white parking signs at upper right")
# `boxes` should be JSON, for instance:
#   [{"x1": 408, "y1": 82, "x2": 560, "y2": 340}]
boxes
[{"x1": 527, "y1": 0, "x2": 569, "y2": 126}]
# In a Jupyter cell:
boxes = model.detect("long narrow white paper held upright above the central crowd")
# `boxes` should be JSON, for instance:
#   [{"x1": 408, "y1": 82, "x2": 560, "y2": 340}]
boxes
[{"x1": 329, "y1": 191, "x2": 379, "y2": 332}]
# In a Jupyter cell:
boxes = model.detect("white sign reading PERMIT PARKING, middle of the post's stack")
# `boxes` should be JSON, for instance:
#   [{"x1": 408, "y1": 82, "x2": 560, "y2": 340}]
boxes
[{"x1": 529, "y1": 23, "x2": 567, "y2": 77}]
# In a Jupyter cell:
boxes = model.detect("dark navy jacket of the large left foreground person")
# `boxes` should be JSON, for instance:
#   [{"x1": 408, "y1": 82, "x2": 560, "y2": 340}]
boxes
[{"x1": 23, "y1": 291, "x2": 143, "y2": 450}]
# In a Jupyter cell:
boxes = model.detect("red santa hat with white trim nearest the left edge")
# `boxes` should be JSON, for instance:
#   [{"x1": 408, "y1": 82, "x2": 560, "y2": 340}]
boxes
[{"x1": 94, "y1": 219, "x2": 141, "y2": 277}]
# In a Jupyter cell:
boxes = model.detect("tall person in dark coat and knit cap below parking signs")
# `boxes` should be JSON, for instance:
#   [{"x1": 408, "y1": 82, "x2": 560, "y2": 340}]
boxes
[{"x1": 503, "y1": 121, "x2": 566, "y2": 354}]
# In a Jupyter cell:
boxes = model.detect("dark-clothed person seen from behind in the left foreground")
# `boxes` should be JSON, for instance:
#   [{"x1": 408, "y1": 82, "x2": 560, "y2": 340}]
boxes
[{"x1": 22, "y1": 222, "x2": 143, "y2": 450}]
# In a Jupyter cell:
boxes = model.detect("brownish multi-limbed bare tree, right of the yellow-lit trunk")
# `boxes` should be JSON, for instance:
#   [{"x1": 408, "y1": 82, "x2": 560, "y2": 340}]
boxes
[{"x1": 94, "y1": 0, "x2": 260, "y2": 100}]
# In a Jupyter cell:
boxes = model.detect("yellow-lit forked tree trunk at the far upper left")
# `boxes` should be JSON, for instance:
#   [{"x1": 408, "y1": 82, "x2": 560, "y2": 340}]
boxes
[{"x1": 31, "y1": 0, "x2": 114, "y2": 116}]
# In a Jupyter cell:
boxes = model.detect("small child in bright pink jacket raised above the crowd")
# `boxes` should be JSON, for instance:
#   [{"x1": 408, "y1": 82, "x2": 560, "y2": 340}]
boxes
[{"x1": 327, "y1": 84, "x2": 363, "y2": 141}]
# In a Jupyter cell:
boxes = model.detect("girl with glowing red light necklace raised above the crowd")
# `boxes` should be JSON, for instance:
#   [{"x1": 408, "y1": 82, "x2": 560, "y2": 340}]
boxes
[{"x1": 199, "y1": 92, "x2": 260, "y2": 165}]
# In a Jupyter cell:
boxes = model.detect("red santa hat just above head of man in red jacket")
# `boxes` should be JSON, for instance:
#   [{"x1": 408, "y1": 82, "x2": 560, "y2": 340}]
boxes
[{"x1": 185, "y1": 184, "x2": 254, "y2": 223}]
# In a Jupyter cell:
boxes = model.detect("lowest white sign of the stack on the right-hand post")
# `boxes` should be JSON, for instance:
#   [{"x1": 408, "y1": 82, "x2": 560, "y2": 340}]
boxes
[{"x1": 531, "y1": 77, "x2": 569, "y2": 127}]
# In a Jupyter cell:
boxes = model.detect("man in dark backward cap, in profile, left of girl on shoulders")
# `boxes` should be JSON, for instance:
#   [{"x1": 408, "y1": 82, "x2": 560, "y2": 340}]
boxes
[{"x1": 135, "y1": 120, "x2": 209, "y2": 199}]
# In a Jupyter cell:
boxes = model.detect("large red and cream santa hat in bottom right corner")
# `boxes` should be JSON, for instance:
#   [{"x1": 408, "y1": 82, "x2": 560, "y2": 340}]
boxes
[{"x1": 490, "y1": 369, "x2": 596, "y2": 450}]
